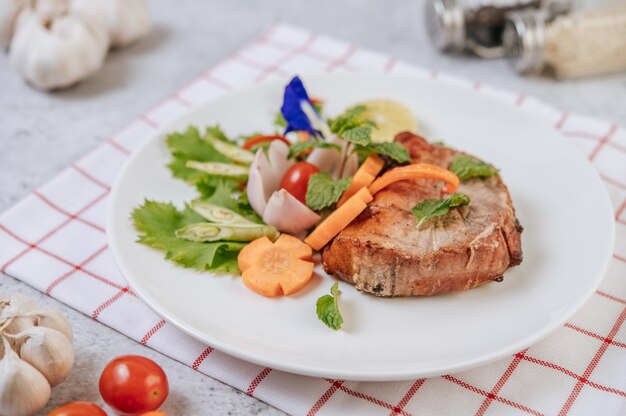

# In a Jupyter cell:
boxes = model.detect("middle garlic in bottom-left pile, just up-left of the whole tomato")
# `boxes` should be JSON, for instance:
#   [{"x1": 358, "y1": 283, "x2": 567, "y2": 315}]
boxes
[{"x1": 15, "y1": 326, "x2": 74, "y2": 387}]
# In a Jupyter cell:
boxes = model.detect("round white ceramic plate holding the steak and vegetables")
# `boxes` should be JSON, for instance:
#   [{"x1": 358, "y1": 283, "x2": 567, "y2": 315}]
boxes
[{"x1": 108, "y1": 75, "x2": 614, "y2": 380}]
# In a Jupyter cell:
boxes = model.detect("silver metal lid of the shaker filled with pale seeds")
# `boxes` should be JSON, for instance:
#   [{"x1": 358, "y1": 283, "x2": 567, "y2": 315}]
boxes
[{"x1": 502, "y1": 11, "x2": 548, "y2": 74}]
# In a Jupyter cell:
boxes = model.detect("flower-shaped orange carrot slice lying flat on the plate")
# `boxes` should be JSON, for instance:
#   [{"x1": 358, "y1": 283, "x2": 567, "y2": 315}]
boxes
[{"x1": 237, "y1": 234, "x2": 314, "y2": 297}]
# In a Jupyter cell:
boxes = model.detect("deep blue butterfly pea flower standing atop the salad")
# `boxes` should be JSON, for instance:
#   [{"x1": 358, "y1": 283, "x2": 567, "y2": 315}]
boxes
[{"x1": 280, "y1": 76, "x2": 324, "y2": 137}]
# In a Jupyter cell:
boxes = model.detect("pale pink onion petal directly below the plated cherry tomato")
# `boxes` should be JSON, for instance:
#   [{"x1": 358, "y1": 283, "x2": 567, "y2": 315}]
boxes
[{"x1": 263, "y1": 189, "x2": 320, "y2": 234}]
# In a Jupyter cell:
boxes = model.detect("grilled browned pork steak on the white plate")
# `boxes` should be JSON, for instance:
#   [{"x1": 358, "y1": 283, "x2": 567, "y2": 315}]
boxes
[{"x1": 322, "y1": 133, "x2": 522, "y2": 296}]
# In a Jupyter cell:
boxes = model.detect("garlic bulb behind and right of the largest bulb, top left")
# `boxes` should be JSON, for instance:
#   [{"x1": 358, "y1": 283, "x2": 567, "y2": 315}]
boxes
[{"x1": 75, "y1": 0, "x2": 151, "y2": 47}]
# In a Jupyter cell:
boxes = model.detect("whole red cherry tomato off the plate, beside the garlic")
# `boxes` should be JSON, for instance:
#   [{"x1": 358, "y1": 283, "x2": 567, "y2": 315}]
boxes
[{"x1": 99, "y1": 355, "x2": 169, "y2": 415}]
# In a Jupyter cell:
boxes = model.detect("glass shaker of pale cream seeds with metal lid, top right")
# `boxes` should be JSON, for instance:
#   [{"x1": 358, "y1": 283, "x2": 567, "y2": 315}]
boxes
[{"x1": 503, "y1": 6, "x2": 626, "y2": 79}]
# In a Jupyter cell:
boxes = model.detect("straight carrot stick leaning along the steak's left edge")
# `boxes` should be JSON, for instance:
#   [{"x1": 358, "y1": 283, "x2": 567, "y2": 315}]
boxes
[{"x1": 304, "y1": 188, "x2": 373, "y2": 250}]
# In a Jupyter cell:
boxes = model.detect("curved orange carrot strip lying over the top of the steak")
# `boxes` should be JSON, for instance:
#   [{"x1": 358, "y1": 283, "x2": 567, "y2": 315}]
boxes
[{"x1": 369, "y1": 163, "x2": 460, "y2": 195}]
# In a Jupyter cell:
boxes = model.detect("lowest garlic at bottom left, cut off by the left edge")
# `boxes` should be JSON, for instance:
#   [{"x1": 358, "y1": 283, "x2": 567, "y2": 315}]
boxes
[{"x1": 0, "y1": 337, "x2": 50, "y2": 416}]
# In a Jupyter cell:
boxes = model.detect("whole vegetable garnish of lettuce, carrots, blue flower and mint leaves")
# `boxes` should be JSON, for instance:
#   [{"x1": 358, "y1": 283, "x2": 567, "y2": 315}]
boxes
[{"x1": 132, "y1": 77, "x2": 468, "y2": 329}]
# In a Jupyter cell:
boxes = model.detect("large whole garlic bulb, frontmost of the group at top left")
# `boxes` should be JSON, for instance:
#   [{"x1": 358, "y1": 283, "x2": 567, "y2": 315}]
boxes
[{"x1": 9, "y1": 0, "x2": 109, "y2": 90}]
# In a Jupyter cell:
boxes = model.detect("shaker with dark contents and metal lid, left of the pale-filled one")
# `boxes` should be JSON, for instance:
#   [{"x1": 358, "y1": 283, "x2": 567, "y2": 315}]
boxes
[{"x1": 425, "y1": 0, "x2": 571, "y2": 58}]
